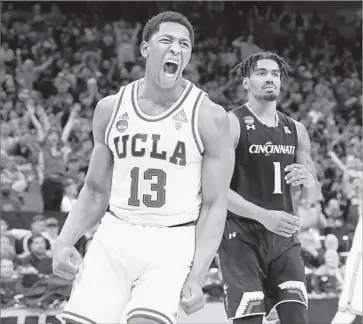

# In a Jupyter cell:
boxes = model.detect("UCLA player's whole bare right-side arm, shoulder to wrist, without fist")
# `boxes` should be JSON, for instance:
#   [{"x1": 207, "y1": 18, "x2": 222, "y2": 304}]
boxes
[{"x1": 189, "y1": 98, "x2": 233, "y2": 284}]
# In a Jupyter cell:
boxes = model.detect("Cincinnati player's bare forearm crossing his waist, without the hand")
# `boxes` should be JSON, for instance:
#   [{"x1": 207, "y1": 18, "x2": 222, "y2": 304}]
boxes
[{"x1": 228, "y1": 189, "x2": 266, "y2": 221}]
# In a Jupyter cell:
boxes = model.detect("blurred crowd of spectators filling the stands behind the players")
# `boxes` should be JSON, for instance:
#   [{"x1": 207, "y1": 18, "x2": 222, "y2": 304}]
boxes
[{"x1": 0, "y1": 1, "x2": 362, "y2": 306}]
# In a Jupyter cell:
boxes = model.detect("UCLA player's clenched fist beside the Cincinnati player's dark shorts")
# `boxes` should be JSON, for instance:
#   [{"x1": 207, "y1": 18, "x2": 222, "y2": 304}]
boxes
[{"x1": 180, "y1": 279, "x2": 205, "y2": 315}]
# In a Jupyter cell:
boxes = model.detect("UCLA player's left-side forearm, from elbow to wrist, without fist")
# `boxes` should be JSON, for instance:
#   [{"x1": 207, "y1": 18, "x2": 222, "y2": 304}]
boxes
[{"x1": 58, "y1": 183, "x2": 109, "y2": 246}]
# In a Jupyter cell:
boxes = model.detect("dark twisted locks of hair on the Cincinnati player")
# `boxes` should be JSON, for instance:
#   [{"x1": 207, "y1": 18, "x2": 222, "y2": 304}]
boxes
[{"x1": 230, "y1": 52, "x2": 290, "y2": 81}]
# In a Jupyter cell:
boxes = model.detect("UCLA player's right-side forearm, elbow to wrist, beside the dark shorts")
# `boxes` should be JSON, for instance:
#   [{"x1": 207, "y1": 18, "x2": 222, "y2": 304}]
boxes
[{"x1": 189, "y1": 205, "x2": 227, "y2": 285}]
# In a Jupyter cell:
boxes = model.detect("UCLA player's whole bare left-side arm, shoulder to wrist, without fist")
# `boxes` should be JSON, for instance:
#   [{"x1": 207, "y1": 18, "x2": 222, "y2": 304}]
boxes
[{"x1": 58, "y1": 96, "x2": 116, "y2": 246}]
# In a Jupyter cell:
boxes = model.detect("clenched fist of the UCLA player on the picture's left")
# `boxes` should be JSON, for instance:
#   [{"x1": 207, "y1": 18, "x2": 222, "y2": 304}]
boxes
[{"x1": 53, "y1": 243, "x2": 80, "y2": 280}]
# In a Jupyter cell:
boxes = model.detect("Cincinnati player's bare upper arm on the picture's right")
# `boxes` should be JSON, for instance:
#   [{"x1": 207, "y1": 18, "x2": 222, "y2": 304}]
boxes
[{"x1": 296, "y1": 123, "x2": 316, "y2": 178}]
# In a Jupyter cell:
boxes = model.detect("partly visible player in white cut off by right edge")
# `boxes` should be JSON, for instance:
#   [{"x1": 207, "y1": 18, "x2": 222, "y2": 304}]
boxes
[{"x1": 332, "y1": 178, "x2": 363, "y2": 324}]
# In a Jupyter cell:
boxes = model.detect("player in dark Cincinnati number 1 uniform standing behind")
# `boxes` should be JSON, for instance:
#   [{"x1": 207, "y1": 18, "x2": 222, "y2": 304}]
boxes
[{"x1": 220, "y1": 52, "x2": 317, "y2": 324}]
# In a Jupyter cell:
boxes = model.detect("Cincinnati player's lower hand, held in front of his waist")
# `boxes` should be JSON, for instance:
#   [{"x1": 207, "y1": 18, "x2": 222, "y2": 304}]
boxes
[{"x1": 260, "y1": 210, "x2": 301, "y2": 237}]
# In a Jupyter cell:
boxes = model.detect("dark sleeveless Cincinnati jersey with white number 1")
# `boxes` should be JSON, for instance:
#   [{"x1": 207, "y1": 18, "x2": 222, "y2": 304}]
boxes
[{"x1": 228, "y1": 105, "x2": 298, "y2": 216}]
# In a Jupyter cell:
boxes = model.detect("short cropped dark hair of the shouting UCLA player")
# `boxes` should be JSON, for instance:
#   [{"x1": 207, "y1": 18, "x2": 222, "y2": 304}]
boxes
[{"x1": 142, "y1": 11, "x2": 195, "y2": 45}]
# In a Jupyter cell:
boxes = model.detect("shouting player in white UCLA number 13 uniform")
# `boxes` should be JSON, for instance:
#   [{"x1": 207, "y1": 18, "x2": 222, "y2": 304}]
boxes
[{"x1": 54, "y1": 12, "x2": 233, "y2": 324}]
